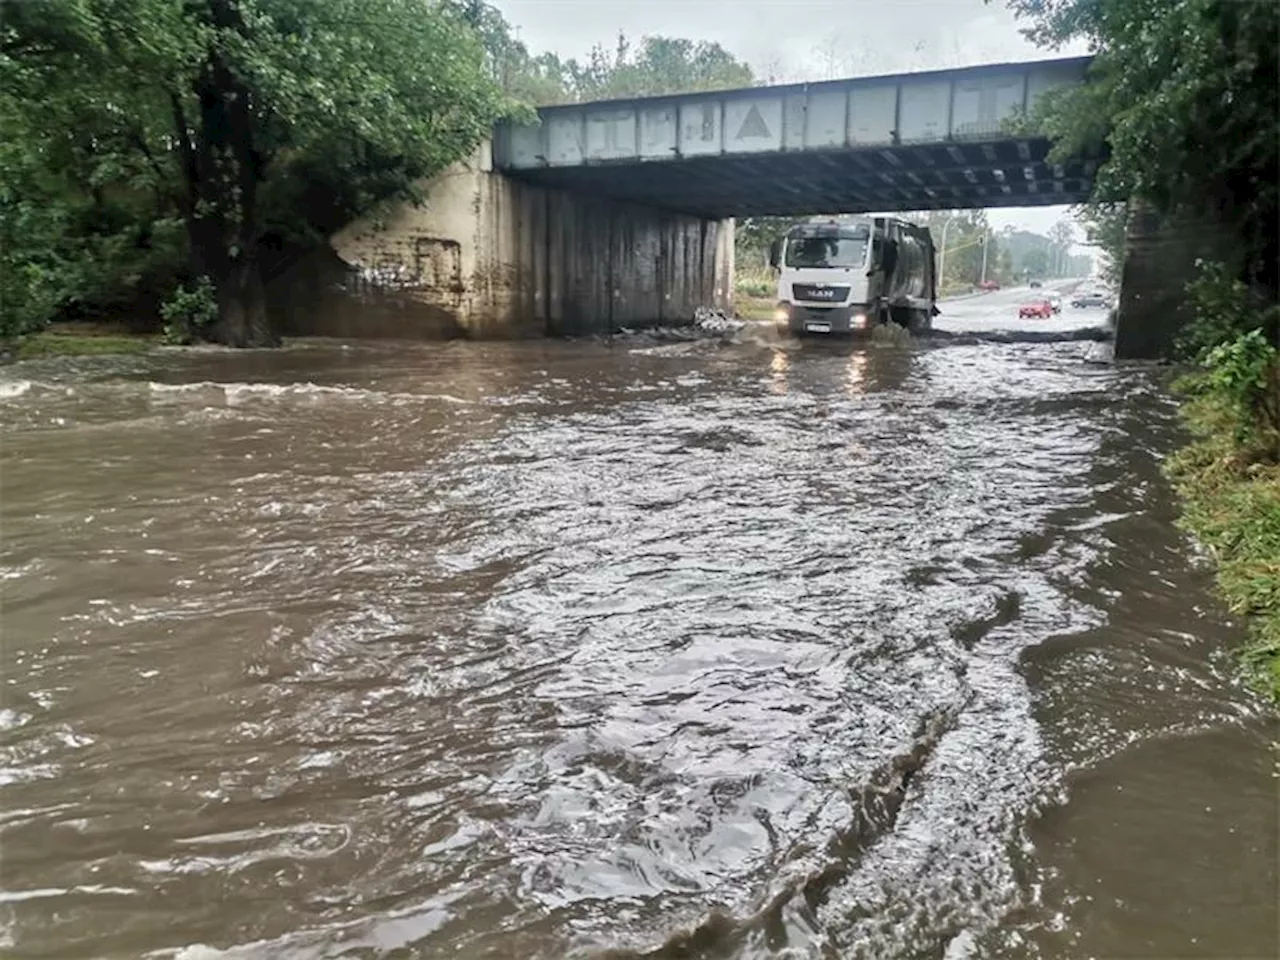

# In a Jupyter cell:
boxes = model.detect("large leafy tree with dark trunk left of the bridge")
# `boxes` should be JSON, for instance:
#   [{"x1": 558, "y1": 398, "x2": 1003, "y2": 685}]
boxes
[{"x1": 0, "y1": 0, "x2": 512, "y2": 346}]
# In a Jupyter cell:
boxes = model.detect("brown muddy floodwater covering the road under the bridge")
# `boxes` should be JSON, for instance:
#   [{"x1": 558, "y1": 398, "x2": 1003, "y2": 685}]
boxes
[{"x1": 0, "y1": 332, "x2": 1277, "y2": 960}]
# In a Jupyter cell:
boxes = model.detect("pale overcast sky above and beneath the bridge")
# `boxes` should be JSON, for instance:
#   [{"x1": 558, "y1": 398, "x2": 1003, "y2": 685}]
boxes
[{"x1": 490, "y1": 0, "x2": 1087, "y2": 248}]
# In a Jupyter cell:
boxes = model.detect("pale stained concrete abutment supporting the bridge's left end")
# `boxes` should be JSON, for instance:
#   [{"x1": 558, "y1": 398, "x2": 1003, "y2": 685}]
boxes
[{"x1": 287, "y1": 143, "x2": 733, "y2": 338}]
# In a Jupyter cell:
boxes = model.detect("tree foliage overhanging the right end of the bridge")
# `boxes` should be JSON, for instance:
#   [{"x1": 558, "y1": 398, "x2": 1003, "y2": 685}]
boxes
[{"x1": 1006, "y1": 0, "x2": 1280, "y2": 297}]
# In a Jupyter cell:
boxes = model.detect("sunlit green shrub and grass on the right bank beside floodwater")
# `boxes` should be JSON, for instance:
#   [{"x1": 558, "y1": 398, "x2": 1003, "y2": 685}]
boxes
[{"x1": 1167, "y1": 264, "x2": 1280, "y2": 699}]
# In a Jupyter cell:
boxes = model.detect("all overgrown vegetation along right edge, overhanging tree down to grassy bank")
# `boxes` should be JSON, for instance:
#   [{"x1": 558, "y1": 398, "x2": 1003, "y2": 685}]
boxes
[{"x1": 1009, "y1": 0, "x2": 1280, "y2": 698}]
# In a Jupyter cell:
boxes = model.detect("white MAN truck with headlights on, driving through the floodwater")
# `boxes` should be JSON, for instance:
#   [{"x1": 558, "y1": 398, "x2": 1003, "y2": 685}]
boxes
[{"x1": 769, "y1": 216, "x2": 938, "y2": 334}]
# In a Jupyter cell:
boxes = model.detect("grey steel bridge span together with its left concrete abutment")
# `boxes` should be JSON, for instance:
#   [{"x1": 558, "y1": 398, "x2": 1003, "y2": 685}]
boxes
[{"x1": 317, "y1": 58, "x2": 1141, "y2": 348}]
